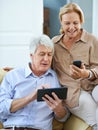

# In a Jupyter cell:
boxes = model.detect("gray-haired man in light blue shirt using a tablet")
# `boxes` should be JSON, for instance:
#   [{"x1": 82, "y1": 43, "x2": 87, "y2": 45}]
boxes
[{"x1": 0, "y1": 35, "x2": 68, "y2": 130}]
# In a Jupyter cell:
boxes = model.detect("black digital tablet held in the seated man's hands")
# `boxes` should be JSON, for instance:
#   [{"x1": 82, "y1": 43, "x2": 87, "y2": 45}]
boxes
[{"x1": 37, "y1": 87, "x2": 67, "y2": 101}]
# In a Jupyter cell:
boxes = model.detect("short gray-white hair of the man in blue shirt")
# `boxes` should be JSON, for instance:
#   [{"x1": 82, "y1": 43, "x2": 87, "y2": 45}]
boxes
[{"x1": 29, "y1": 34, "x2": 54, "y2": 54}]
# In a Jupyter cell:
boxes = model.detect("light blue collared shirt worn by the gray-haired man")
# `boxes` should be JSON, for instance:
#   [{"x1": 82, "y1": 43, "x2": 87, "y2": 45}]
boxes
[{"x1": 0, "y1": 66, "x2": 60, "y2": 130}]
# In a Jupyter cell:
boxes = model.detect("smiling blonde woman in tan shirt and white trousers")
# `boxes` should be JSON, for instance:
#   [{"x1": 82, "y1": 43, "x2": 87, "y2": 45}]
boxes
[{"x1": 53, "y1": 3, "x2": 98, "y2": 130}]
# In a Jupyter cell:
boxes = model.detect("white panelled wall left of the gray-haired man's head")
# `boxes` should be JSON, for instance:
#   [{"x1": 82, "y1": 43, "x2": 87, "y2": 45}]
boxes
[{"x1": 0, "y1": 0, "x2": 43, "y2": 67}]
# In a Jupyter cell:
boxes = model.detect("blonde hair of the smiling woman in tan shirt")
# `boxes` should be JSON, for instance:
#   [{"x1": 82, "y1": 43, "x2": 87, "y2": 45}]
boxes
[{"x1": 59, "y1": 3, "x2": 84, "y2": 33}]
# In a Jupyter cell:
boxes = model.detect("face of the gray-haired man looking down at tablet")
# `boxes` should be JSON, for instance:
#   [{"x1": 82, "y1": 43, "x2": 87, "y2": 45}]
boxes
[{"x1": 30, "y1": 45, "x2": 53, "y2": 76}]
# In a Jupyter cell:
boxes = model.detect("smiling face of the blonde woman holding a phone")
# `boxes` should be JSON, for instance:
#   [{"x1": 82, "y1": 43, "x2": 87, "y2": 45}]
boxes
[{"x1": 61, "y1": 12, "x2": 81, "y2": 38}]
